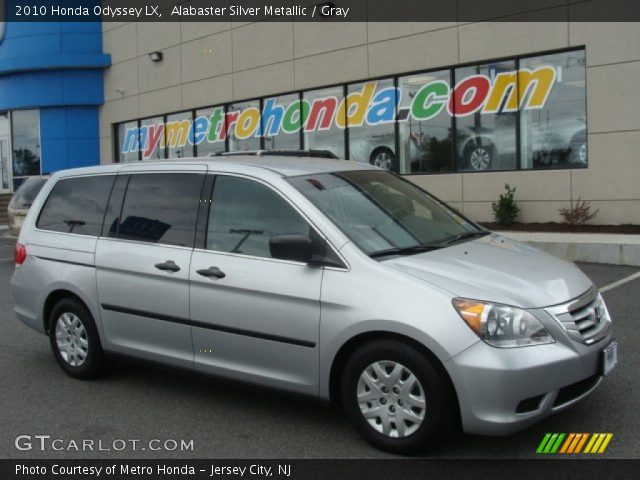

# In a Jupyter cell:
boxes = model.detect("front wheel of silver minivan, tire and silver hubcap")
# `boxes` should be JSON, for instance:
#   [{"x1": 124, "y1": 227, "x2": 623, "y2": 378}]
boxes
[{"x1": 341, "y1": 340, "x2": 456, "y2": 453}]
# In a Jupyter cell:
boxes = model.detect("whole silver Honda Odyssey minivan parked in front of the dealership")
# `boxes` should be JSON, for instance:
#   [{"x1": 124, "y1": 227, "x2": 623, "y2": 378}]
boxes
[{"x1": 11, "y1": 156, "x2": 617, "y2": 452}]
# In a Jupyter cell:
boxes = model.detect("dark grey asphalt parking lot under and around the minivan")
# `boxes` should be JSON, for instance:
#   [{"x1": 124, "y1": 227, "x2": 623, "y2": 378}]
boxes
[{"x1": 0, "y1": 234, "x2": 640, "y2": 459}]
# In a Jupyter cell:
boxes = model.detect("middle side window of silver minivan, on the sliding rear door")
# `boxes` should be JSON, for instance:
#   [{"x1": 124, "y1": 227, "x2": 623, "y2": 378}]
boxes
[{"x1": 118, "y1": 173, "x2": 204, "y2": 247}]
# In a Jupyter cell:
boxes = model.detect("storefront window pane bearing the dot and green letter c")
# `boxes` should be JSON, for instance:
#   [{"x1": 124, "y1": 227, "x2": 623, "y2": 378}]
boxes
[{"x1": 398, "y1": 70, "x2": 453, "y2": 173}]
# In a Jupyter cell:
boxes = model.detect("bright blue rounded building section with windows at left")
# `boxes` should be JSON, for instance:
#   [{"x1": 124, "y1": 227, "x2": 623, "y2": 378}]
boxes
[{"x1": 0, "y1": 22, "x2": 110, "y2": 189}]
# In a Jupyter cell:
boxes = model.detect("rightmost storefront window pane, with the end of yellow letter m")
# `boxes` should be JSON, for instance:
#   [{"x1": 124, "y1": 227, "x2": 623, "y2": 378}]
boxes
[{"x1": 519, "y1": 50, "x2": 587, "y2": 169}]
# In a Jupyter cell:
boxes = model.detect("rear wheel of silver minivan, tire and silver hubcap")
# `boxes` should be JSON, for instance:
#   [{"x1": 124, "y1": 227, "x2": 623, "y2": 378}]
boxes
[{"x1": 49, "y1": 298, "x2": 104, "y2": 379}]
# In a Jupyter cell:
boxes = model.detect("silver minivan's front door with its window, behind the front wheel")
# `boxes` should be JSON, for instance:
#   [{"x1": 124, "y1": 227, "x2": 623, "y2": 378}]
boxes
[{"x1": 189, "y1": 175, "x2": 323, "y2": 394}]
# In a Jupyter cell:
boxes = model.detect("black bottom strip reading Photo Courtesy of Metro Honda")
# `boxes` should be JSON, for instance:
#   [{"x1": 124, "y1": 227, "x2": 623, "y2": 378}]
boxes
[{"x1": 0, "y1": 459, "x2": 640, "y2": 480}]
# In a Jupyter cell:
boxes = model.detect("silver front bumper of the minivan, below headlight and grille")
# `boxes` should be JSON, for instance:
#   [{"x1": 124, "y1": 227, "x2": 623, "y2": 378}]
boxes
[{"x1": 445, "y1": 333, "x2": 611, "y2": 435}]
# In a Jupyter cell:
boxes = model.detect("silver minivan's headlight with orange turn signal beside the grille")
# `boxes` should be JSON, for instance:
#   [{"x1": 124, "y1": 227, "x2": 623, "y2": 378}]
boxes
[{"x1": 453, "y1": 298, "x2": 555, "y2": 348}]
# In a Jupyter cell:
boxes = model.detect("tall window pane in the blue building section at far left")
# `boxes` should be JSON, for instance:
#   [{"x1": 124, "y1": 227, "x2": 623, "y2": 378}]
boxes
[{"x1": 11, "y1": 110, "x2": 40, "y2": 189}]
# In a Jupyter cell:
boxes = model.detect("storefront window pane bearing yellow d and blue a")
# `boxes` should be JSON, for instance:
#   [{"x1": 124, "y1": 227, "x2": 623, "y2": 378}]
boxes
[{"x1": 346, "y1": 78, "x2": 397, "y2": 171}]
